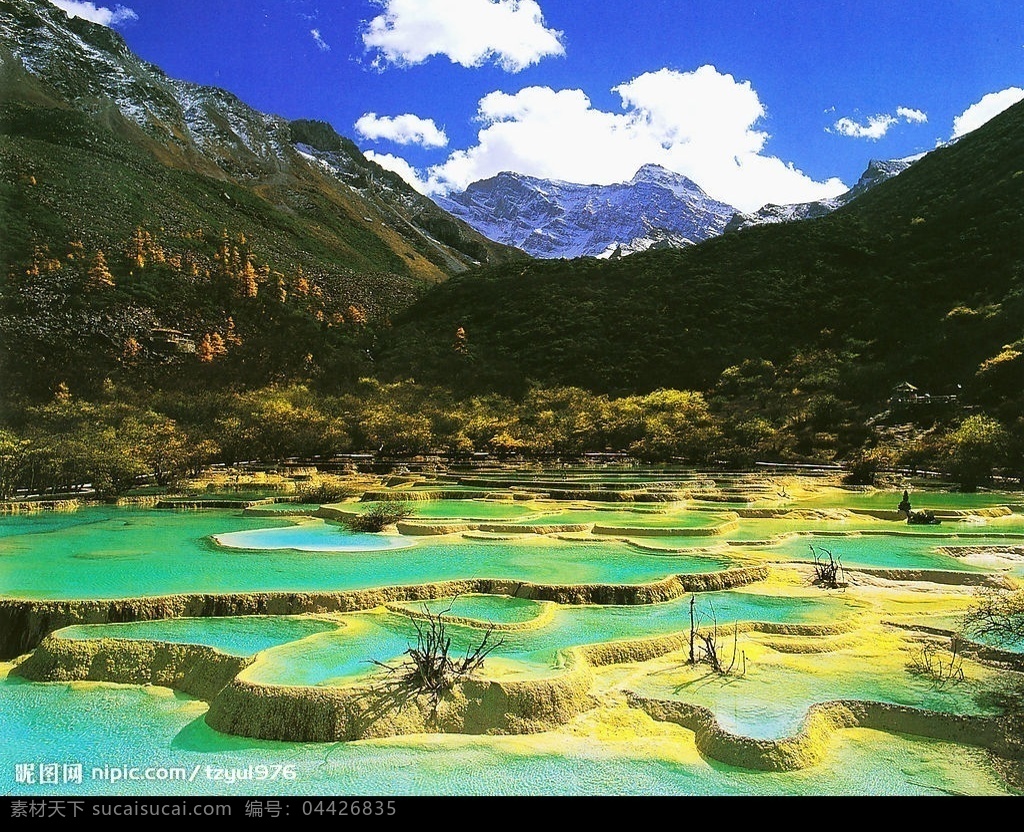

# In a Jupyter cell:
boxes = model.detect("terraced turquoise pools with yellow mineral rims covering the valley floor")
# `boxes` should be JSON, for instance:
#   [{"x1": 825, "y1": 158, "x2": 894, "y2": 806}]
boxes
[{"x1": 0, "y1": 469, "x2": 1024, "y2": 795}]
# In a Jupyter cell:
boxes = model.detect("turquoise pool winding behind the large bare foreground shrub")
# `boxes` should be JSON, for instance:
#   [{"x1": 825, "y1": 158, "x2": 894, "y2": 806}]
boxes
[{"x1": 247, "y1": 591, "x2": 860, "y2": 685}]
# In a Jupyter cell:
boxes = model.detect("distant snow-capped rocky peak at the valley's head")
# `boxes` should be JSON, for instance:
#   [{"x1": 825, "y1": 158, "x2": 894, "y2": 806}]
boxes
[{"x1": 435, "y1": 165, "x2": 736, "y2": 258}]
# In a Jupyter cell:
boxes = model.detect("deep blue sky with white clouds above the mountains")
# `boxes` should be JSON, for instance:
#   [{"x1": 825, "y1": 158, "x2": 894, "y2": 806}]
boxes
[{"x1": 52, "y1": 0, "x2": 1024, "y2": 210}]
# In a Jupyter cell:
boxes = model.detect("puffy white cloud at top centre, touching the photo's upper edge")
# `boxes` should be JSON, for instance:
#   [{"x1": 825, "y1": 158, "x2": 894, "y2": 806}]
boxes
[{"x1": 362, "y1": 0, "x2": 565, "y2": 72}]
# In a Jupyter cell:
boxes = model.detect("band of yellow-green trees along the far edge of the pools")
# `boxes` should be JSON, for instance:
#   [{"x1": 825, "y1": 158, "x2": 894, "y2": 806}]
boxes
[{"x1": 0, "y1": 378, "x2": 1024, "y2": 499}]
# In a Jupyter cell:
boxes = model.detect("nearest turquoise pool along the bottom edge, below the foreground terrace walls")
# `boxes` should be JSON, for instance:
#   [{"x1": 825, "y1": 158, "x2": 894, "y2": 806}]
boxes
[{"x1": 0, "y1": 676, "x2": 1009, "y2": 797}]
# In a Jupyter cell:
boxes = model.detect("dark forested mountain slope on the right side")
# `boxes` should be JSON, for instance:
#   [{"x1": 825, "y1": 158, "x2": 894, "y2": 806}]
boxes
[{"x1": 376, "y1": 97, "x2": 1024, "y2": 422}]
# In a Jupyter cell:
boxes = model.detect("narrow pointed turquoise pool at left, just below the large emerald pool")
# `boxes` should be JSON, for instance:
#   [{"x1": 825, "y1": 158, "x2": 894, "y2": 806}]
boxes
[{"x1": 57, "y1": 616, "x2": 337, "y2": 656}]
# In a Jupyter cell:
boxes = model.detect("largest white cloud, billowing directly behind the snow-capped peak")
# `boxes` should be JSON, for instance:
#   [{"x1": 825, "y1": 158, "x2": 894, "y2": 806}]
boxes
[{"x1": 403, "y1": 66, "x2": 847, "y2": 210}]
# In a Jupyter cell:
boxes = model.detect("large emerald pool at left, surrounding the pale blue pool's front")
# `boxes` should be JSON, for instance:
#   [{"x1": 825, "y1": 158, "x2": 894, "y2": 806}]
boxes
[{"x1": 0, "y1": 507, "x2": 731, "y2": 598}]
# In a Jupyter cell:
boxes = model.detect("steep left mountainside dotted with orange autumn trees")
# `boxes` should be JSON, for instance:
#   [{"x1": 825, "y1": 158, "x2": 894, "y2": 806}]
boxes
[{"x1": 0, "y1": 0, "x2": 525, "y2": 397}]
